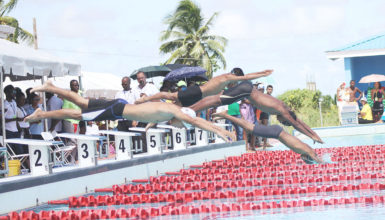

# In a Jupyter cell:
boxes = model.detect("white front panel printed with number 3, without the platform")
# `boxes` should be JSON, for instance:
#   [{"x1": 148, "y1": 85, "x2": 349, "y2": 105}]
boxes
[{"x1": 78, "y1": 139, "x2": 96, "y2": 167}]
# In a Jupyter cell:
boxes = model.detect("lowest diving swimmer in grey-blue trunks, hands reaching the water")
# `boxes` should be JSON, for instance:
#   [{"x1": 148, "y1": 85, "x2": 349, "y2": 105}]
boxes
[{"x1": 213, "y1": 112, "x2": 323, "y2": 164}]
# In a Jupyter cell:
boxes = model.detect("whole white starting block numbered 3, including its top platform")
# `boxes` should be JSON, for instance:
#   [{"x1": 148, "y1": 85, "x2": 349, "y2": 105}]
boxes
[{"x1": 57, "y1": 133, "x2": 100, "y2": 167}]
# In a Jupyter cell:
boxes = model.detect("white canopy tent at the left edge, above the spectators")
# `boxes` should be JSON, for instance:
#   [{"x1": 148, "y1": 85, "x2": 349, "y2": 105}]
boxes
[{"x1": 0, "y1": 39, "x2": 80, "y2": 139}]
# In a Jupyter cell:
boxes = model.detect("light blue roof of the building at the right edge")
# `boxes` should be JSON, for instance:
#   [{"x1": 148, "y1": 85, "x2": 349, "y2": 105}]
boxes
[{"x1": 326, "y1": 34, "x2": 385, "y2": 60}]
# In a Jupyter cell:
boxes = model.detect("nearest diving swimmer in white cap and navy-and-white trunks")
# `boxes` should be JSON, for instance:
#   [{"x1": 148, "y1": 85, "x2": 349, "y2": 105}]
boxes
[{"x1": 24, "y1": 81, "x2": 235, "y2": 142}]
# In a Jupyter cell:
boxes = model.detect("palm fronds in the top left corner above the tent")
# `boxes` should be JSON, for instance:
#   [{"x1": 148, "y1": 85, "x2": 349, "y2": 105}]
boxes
[{"x1": 0, "y1": 0, "x2": 33, "y2": 44}]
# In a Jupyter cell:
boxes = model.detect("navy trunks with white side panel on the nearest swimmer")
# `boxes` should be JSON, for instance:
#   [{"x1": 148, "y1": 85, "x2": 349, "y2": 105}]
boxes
[{"x1": 82, "y1": 99, "x2": 128, "y2": 121}]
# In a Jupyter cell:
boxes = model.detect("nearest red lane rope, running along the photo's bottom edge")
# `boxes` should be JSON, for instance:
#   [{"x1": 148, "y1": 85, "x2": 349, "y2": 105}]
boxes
[{"x1": 8, "y1": 196, "x2": 385, "y2": 220}]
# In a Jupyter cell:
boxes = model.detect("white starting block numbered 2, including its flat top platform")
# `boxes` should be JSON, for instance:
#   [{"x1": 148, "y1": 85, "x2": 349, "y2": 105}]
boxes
[{"x1": 5, "y1": 138, "x2": 53, "y2": 176}]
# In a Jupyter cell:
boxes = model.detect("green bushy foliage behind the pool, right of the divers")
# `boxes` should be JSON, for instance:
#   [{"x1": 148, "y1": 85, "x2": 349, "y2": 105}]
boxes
[{"x1": 278, "y1": 89, "x2": 339, "y2": 127}]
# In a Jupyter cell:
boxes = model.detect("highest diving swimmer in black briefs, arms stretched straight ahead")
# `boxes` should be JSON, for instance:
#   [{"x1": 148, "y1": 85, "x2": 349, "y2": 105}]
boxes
[{"x1": 135, "y1": 70, "x2": 273, "y2": 107}]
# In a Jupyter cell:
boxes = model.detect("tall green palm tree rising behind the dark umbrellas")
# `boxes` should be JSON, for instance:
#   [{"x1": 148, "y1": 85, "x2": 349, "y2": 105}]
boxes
[{"x1": 160, "y1": 0, "x2": 227, "y2": 79}]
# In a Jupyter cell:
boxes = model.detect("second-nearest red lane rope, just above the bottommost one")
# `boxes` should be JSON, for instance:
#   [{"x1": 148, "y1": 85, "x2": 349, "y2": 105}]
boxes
[{"x1": 57, "y1": 183, "x2": 385, "y2": 208}]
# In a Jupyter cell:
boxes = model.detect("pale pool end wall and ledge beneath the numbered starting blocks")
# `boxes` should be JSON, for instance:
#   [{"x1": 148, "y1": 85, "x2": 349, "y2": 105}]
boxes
[{"x1": 0, "y1": 141, "x2": 246, "y2": 214}]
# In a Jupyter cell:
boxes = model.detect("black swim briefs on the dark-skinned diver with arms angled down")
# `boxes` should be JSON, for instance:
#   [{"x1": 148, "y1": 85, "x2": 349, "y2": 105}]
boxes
[{"x1": 220, "y1": 81, "x2": 253, "y2": 105}]
